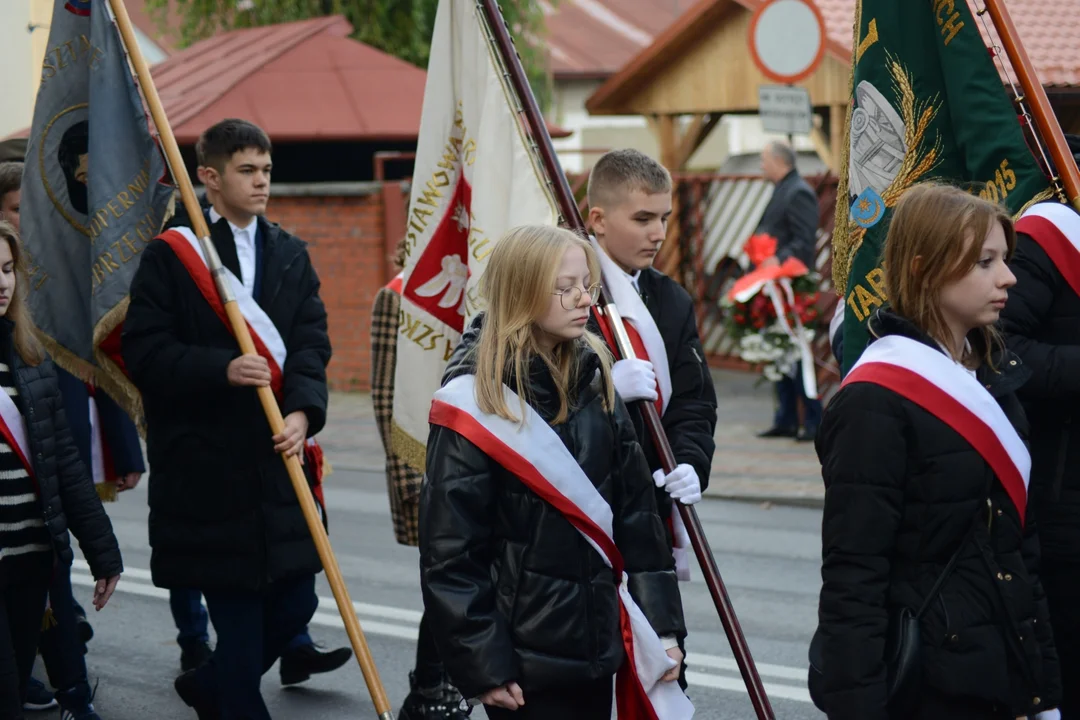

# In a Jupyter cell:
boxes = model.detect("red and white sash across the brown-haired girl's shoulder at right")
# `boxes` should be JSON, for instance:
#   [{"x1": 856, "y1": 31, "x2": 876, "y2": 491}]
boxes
[{"x1": 841, "y1": 335, "x2": 1031, "y2": 525}]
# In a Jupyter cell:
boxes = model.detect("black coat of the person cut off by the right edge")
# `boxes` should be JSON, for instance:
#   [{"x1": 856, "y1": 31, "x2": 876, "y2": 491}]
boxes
[{"x1": 1001, "y1": 233, "x2": 1080, "y2": 562}]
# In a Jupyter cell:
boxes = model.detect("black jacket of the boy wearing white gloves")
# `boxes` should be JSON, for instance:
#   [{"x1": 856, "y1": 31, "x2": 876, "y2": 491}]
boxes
[{"x1": 590, "y1": 268, "x2": 716, "y2": 519}]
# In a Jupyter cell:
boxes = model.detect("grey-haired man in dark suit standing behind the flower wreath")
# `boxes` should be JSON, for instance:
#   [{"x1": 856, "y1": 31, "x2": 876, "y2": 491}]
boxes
[{"x1": 756, "y1": 142, "x2": 821, "y2": 441}]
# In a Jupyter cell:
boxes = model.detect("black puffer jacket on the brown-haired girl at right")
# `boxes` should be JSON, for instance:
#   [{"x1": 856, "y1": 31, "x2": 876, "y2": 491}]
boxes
[{"x1": 816, "y1": 311, "x2": 1061, "y2": 720}]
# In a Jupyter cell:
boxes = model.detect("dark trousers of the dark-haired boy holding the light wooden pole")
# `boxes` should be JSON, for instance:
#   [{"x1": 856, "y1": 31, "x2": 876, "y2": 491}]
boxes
[{"x1": 195, "y1": 575, "x2": 319, "y2": 720}]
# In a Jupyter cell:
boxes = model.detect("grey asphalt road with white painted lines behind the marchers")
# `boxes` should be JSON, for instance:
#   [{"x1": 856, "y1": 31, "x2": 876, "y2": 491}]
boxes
[{"x1": 38, "y1": 468, "x2": 822, "y2": 720}]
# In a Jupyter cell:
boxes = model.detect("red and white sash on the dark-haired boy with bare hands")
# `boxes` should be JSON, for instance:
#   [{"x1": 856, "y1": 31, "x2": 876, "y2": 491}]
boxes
[{"x1": 159, "y1": 227, "x2": 323, "y2": 490}]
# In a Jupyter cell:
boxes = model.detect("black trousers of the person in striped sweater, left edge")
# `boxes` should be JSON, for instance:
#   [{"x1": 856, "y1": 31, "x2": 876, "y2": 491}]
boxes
[{"x1": 0, "y1": 553, "x2": 52, "y2": 720}]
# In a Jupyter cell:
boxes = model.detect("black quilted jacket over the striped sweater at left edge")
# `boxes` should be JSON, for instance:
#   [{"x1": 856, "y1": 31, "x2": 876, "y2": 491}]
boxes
[{"x1": 0, "y1": 318, "x2": 124, "y2": 580}]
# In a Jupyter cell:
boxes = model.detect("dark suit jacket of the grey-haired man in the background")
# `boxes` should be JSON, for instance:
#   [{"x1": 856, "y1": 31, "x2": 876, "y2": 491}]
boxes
[{"x1": 757, "y1": 169, "x2": 821, "y2": 270}]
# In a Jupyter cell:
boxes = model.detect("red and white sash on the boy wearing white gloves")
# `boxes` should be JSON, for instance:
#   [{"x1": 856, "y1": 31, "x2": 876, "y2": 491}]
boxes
[{"x1": 590, "y1": 237, "x2": 690, "y2": 581}]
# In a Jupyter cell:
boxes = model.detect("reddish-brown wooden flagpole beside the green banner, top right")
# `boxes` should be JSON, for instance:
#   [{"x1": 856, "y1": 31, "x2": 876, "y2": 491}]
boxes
[{"x1": 985, "y1": 0, "x2": 1080, "y2": 210}]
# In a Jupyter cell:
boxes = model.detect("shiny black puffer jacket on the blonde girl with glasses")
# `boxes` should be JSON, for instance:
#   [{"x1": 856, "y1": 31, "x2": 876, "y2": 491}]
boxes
[{"x1": 420, "y1": 320, "x2": 685, "y2": 697}]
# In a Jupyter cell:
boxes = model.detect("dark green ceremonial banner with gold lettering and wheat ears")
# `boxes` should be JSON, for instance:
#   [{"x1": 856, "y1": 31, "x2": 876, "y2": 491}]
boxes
[{"x1": 833, "y1": 0, "x2": 1051, "y2": 372}]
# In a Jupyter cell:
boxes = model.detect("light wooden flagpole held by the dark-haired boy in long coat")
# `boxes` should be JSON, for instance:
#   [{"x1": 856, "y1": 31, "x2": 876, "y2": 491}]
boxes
[{"x1": 109, "y1": 0, "x2": 393, "y2": 720}]
